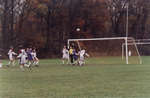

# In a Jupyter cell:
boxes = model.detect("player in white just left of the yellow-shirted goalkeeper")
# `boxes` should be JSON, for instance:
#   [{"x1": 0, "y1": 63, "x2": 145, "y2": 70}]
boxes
[{"x1": 62, "y1": 46, "x2": 69, "y2": 64}]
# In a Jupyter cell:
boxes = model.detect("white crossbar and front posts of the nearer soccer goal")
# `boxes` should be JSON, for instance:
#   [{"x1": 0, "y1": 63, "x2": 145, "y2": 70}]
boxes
[{"x1": 68, "y1": 37, "x2": 131, "y2": 64}]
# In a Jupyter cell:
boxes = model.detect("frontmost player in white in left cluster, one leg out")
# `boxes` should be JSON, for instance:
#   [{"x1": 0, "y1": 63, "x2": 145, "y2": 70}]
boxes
[{"x1": 17, "y1": 49, "x2": 30, "y2": 71}]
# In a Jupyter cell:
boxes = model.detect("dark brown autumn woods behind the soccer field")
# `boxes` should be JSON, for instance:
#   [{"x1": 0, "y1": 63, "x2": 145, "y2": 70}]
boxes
[{"x1": 0, "y1": 0, "x2": 150, "y2": 57}]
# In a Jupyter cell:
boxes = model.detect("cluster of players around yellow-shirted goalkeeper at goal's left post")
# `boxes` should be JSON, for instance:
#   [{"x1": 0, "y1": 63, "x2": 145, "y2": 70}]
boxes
[{"x1": 62, "y1": 46, "x2": 89, "y2": 66}]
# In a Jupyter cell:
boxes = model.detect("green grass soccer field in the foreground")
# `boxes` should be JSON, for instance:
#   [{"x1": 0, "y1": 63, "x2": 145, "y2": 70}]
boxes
[{"x1": 0, "y1": 57, "x2": 150, "y2": 98}]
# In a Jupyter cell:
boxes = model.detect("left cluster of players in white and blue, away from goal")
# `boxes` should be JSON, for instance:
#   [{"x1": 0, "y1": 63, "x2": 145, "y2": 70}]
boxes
[{"x1": 7, "y1": 48, "x2": 39, "y2": 70}]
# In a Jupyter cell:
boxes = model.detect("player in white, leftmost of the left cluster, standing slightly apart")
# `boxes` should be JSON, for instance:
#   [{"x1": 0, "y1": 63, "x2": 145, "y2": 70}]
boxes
[{"x1": 8, "y1": 48, "x2": 17, "y2": 66}]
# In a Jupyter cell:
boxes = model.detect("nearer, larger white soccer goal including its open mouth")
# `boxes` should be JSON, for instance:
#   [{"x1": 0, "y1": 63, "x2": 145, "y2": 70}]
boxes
[{"x1": 68, "y1": 37, "x2": 138, "y2": 64}]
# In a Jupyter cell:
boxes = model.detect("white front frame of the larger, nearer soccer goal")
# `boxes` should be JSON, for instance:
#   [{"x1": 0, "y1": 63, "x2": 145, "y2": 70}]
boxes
[{"x1": 67, "y1": 37, "x2": 138, "y2": 64}]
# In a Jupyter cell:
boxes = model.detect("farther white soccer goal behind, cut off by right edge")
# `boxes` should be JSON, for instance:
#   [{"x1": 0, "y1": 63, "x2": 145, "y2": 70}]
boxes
[{"x1": 122, "y1": 39, "x2": 150, "y2": 64}]
